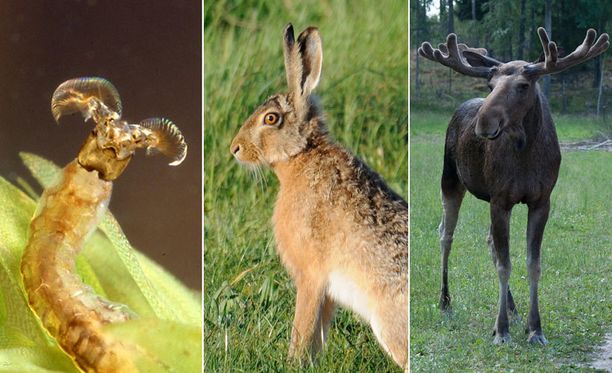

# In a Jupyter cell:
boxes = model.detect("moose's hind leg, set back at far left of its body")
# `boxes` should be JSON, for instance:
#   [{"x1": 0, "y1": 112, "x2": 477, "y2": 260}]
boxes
[{"x1": 438, "y1": 179, "x2": 465, "y2": 310}]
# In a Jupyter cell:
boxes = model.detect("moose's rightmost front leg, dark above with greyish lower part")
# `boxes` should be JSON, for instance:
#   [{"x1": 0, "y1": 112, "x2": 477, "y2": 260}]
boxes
[{"x1": 527, "y1": 200, "x2": 550, "y2": 345}]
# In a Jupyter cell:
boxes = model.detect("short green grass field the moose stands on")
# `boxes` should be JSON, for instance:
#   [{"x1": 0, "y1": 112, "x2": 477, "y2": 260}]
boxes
[{"x1": 410, "y1": 111, "x2": 612, "y2": 372}]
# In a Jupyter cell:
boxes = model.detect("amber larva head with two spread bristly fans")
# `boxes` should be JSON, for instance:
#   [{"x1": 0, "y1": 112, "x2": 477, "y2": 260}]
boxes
[{"x1": 51, "y1": 78, "x2": 187, "y2": 180}]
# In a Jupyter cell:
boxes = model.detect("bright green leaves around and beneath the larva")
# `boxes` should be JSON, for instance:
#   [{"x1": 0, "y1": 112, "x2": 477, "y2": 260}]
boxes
[{"x1": 0, "y1": 153, "x2": 202, "y2": 372}]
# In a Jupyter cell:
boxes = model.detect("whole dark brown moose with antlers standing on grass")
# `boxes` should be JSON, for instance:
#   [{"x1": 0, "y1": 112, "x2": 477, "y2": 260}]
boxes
[{"x1": 418, "y1": 28, "x2": 610, "y2": 345}]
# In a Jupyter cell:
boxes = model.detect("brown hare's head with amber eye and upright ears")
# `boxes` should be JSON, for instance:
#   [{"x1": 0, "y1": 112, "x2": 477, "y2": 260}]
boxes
[{"x1": 230, "y1": 24, "x2": 323, "y2": 165}]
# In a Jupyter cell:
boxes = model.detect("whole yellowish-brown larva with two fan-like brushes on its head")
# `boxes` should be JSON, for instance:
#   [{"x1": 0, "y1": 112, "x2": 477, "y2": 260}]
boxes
[{"x1": 21, "y1": 78, "x2": 187, "y2": 372}]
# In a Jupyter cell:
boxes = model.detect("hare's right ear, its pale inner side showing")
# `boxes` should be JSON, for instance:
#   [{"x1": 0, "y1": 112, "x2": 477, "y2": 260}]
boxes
[{"x1": 298, "y1": 27, "x2": 323, "y2": 98}]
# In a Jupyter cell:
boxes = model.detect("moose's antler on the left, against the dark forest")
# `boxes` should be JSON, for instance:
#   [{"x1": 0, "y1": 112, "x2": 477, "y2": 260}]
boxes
[{"x1": 419, "y1": 34, "x2": 491, "y2": 78}]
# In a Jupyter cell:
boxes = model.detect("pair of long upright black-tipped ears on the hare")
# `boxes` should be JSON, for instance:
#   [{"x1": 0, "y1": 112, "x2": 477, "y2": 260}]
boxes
[{"x1": 283, "y1": 24, "x2": 323, "y2": 110}]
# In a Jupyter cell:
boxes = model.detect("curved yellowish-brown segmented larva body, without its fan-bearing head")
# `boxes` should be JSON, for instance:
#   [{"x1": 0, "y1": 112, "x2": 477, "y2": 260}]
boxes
[{"x1": 21, "y1": 161, "x2": 135, "y2": 372}]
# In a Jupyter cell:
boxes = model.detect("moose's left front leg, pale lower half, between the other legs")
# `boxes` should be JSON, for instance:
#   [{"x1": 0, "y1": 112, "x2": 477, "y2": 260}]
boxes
[{"x1": 491, "y1": 201, "x2": 512, "y2": 344}]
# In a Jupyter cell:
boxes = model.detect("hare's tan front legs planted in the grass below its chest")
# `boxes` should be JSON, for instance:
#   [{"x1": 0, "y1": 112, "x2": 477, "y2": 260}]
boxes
[{"x1": 289, "y1": 279, "x2": 335, "y2": 361}]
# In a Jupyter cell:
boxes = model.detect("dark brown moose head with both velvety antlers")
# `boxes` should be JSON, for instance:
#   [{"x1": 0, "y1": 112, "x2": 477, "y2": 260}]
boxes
[{"x1": 419, "y1": 27, "x2": 610, "y2": 143}]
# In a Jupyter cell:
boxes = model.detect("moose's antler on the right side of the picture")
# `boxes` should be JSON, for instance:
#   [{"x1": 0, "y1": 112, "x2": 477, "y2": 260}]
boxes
[{"x1": 525, "y1": 27, "x2": 610, "y2": 75}]
